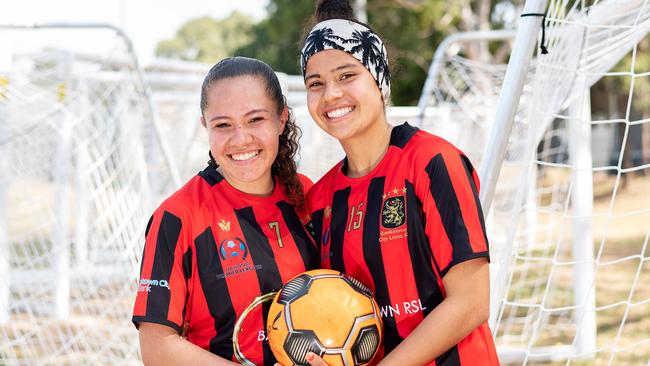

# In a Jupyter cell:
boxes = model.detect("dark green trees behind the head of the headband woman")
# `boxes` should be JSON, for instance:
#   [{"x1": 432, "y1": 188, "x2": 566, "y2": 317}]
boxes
[{"x1": 236, "y1": 0, "x2": 522, "y2": 105}]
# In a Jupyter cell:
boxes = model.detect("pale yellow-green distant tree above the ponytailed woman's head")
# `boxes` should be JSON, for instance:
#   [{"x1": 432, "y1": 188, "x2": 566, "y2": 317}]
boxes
[{"x1": 156, "y1": 12, "x2": 254, "y2": 64}]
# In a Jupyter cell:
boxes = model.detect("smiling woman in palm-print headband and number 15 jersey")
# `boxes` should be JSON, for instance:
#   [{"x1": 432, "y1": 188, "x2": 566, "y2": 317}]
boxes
[{"x1": 301, "y1": 0, "x2": 499, "y2": 366}]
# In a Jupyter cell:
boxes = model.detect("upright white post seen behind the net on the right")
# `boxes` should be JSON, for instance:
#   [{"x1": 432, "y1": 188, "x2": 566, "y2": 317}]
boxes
[{"x1": 569, "y1": 89, "x2": 597, "y2": 356}]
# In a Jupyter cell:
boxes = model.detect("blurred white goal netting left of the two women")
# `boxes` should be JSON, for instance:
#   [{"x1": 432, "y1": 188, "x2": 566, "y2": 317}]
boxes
[{"x1": 0, "y1": 29, "x2": 152, "y2": 365}]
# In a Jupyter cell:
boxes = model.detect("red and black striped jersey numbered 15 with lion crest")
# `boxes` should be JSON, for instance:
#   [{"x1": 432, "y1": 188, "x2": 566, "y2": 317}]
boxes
[{"x1": 308, "y1": 123, "x2": 498, "y2": 365}]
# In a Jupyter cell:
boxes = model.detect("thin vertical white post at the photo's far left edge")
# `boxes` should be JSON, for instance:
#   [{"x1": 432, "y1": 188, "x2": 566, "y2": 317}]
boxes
[{"x1": 0, "y1": 75, "x2": 11, "y2": 325}]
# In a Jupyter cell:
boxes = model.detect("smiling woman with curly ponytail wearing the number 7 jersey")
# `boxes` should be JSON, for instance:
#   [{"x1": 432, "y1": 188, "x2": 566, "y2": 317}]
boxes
[{"x1": 133, "y1": 57, "x2": 318, "y2": 365}]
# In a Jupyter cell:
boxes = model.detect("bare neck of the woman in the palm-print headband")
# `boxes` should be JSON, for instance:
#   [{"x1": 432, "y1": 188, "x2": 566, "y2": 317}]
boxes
[{"x1": 341, "y1": 119, "x2": 393, "y2": 178}]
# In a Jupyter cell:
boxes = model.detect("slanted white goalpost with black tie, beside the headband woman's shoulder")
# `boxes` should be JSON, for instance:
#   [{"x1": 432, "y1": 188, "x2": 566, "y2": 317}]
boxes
[{"x1": 479, "y1": 0, "x2": 547, "y2": 213}]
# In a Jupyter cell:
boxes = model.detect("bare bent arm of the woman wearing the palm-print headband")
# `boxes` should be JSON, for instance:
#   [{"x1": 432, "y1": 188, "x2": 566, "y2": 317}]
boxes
[{"x1": 379, "y1": 258, "x2": 490, "y2": 365}]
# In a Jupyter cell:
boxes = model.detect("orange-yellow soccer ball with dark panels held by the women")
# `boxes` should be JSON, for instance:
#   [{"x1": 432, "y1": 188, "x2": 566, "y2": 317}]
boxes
[{"x1": 266, "y1": 269, "x2": 382, "y2": 366}]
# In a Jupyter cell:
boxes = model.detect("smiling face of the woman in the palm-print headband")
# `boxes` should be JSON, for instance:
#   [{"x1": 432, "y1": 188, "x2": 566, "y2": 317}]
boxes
[{"x1": 305, "y1": 50, "x2": 385, "y2": 143}]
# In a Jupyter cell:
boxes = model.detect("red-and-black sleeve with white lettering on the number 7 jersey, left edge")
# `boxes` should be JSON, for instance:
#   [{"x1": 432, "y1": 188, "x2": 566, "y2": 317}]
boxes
[{"x1": 132, "y1": 207, "x2": 191, "y2": 333}]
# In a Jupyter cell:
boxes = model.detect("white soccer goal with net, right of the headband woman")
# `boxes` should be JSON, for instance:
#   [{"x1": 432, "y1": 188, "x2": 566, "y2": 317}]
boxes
[{"x1": 420, "y1": 0, "x2": 650, "y2": 365}]
